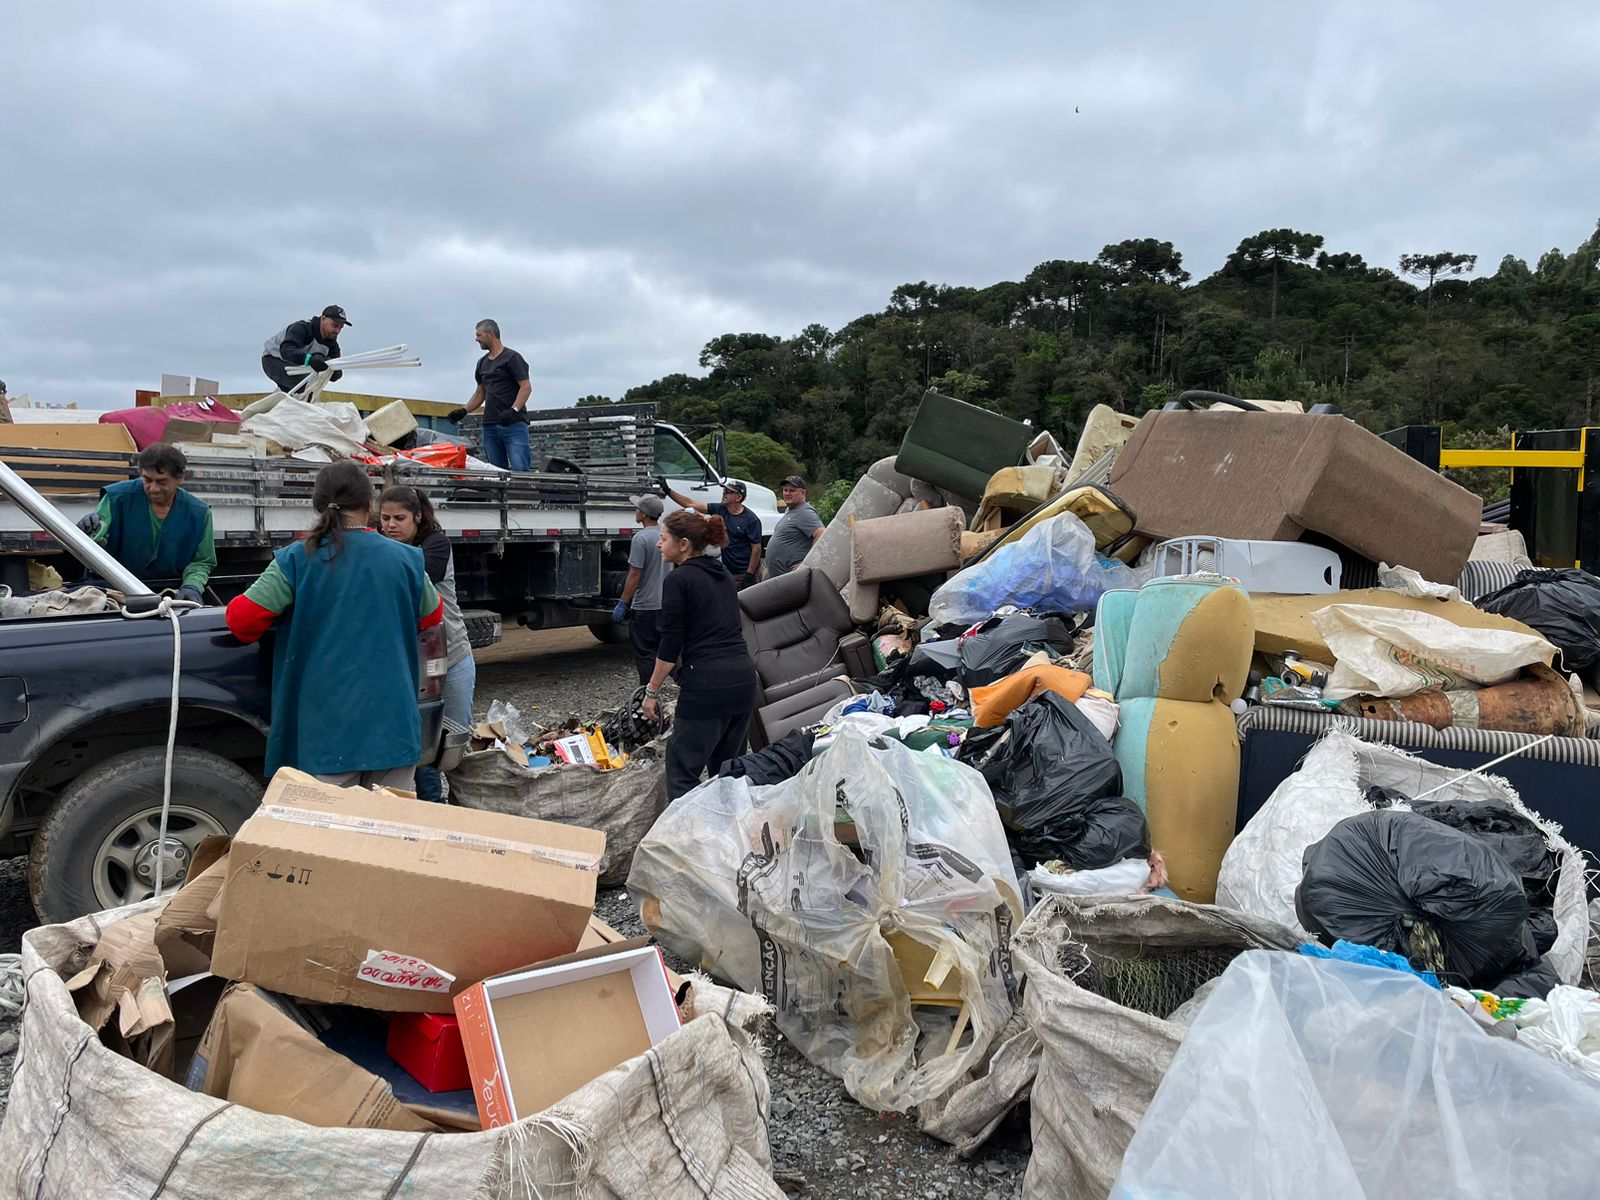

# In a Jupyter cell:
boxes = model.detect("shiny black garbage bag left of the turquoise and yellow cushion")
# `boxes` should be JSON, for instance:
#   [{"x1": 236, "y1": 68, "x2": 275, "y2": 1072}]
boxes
[{"x1": 968, "y1": 691, "x2": 1150, "y2": 870}]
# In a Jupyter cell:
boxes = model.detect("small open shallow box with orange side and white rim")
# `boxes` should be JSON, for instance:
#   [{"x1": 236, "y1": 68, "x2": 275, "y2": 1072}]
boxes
[{"x1": 456, "y1": 938, "x2": 682, "y2": 1130}]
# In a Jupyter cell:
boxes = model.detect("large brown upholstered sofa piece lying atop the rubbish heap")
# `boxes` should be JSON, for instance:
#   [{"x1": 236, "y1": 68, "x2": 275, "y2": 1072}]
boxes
[{"x1": 1107, "y1": 411, "x2": 1483, "y2": 584}]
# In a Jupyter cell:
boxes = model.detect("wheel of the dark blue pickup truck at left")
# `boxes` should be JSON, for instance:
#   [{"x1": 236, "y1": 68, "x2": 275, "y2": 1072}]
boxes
[{"x1": 27, "y1": 746, "x2": 261, "y2": 923}]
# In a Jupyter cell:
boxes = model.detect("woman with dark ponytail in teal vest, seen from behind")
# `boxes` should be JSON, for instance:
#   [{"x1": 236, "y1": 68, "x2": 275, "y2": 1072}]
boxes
[{"x1": 227, "y1": 462, "x2": 445, "y2": 792}]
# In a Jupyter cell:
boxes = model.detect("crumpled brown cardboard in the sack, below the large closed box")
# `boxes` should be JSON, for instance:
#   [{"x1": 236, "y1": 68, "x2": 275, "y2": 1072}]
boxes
[{"x1": 186, "y1": 984, "x2": 437, "y2": 1133}]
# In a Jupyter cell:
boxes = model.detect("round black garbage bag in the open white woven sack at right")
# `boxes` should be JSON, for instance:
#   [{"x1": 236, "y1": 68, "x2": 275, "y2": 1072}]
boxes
[{"x1": 1294, "y1": 808, "x2": 1538, "y2": 987}]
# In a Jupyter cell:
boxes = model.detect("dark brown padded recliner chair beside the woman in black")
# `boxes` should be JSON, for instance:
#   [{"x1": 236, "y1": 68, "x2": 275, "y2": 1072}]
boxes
[{"x1": 739, "y1": 566, "x2": 877, "y2": 749}]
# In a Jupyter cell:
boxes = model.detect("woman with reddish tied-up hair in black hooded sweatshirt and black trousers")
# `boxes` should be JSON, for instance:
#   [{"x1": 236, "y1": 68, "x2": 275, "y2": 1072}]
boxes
[{"x1": 645, "y1": 509, "x2": 755, "y2": 800}]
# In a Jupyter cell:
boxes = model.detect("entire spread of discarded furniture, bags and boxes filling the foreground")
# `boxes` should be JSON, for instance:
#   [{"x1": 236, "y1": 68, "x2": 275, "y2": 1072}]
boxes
[{"x1": 0, "y1": 394, "x2": 1600, "y2": 1200}]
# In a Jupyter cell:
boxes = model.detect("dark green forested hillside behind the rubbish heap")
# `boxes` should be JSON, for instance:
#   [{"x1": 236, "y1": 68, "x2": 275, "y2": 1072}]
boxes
[{"x1": 579, "y1": 226, "x2": 1600, "y2": 499}]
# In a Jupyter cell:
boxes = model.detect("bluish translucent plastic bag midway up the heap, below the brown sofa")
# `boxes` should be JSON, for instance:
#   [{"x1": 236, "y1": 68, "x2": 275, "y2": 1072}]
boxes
[{"x1": 928, "y1": 512, "x2": 1142, "y2": 626}]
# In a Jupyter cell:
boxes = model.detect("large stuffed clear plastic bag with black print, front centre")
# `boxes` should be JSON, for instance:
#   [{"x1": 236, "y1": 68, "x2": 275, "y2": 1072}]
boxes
[{"x1": 627, "y1": 726, "x2": 1021, "y2": 1110}]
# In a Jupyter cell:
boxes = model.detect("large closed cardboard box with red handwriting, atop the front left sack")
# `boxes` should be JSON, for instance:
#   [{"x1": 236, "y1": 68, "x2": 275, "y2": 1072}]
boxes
[{"x1": 211, "y1": 768, "x2": 605, "y2": 1013}]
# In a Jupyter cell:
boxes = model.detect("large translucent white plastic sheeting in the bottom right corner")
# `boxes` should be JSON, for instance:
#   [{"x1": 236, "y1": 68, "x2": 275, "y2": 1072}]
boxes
[{"x1": 1113, "y1": 950, "x2": 1600, "y2": 1200}]
